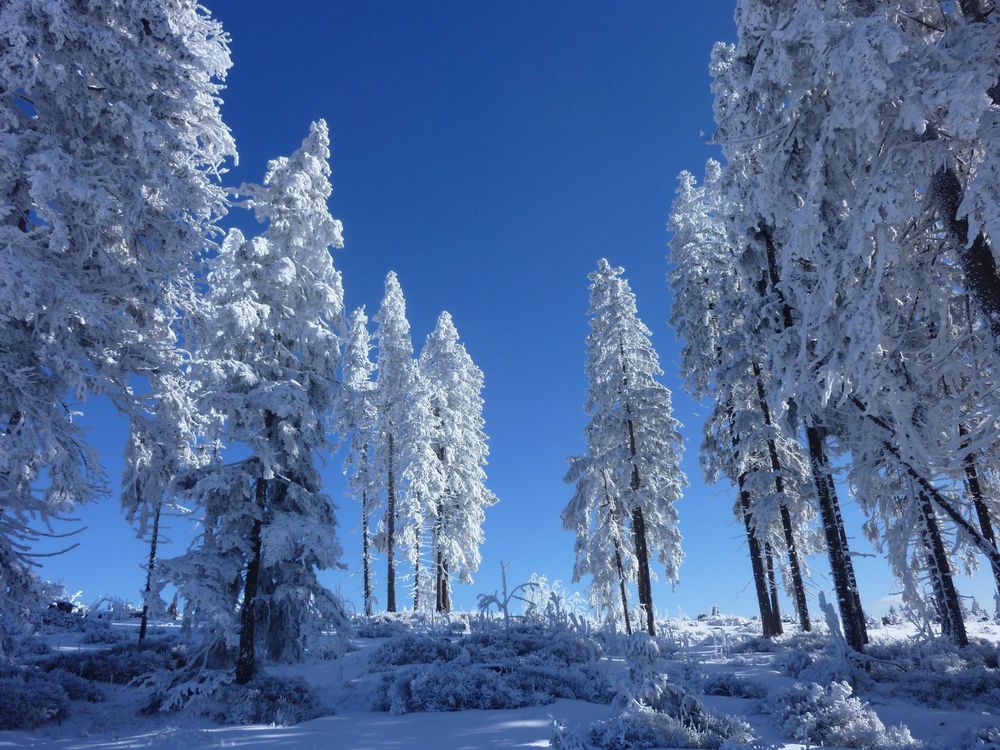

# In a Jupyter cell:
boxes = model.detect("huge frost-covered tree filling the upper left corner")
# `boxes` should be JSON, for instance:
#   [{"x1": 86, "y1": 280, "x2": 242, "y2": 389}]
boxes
[{"x1": 0, "y1": 0, "x2": 235, "y2": 636}]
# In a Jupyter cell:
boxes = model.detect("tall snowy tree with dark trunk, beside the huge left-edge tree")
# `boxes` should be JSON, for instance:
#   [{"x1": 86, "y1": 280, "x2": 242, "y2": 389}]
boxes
[{"x1": 165, "y1": 121, "x2": 345, "y2": 672}]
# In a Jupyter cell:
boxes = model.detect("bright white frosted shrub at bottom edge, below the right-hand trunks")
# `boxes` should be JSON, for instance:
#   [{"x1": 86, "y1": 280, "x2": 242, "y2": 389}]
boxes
[{"x1": 768, "y1": 682, "x2": 919, "y2": 750}]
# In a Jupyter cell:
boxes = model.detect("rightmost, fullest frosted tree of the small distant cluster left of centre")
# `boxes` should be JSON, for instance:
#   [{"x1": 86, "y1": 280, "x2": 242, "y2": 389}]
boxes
[{"x1": 419, "y1": 312, "x2": 496, "y2": 612}]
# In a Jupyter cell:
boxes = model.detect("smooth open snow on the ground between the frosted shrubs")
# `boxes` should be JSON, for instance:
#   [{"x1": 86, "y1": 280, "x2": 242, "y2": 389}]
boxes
[{"x1": 0, "y1": 616, "x2": 1000, "y2": 750}]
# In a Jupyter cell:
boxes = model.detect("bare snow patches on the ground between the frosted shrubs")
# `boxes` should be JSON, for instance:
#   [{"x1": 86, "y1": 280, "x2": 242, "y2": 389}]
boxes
[{"x1": 0, "y1": 615, "x2": 1000, "y2": 750}]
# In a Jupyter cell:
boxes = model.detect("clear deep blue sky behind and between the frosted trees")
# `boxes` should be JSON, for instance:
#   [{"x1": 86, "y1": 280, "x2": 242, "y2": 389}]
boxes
[{"x1": 35, "y1": 0, "x2": 990, "y2": 616}]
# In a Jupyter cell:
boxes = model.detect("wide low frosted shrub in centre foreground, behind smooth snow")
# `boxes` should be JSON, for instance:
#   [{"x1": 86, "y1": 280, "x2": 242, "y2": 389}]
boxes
[{"x1": 372, "y1": 662, "x2": 611, "y2": 714}]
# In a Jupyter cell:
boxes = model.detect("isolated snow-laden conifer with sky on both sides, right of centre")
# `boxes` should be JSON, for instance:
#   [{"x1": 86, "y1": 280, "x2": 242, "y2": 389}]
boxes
[{"x1": 563, "y1": 258, "x2": 687, "y2": 633}]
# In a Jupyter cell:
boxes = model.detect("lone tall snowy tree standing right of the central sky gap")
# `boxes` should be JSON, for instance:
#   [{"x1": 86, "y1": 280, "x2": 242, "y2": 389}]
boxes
[{"x1": 586, "y1": 258, "x2": 687, "y2": 635}]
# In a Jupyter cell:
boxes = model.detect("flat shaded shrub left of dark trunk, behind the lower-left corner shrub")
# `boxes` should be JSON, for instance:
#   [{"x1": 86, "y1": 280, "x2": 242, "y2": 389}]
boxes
[{"x1": 40, "y1": 641, "x2": 185, "y2": 684}]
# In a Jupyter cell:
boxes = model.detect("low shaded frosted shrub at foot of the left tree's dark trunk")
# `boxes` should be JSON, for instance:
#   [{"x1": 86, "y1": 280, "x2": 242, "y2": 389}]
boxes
[{"x1": 215, "y1": 675, "x2": 330, "y2": 726}]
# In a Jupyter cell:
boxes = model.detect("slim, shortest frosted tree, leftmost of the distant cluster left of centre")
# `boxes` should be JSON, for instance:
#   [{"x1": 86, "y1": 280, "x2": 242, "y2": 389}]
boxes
[{"x1": 336, "y1": 307, "x2": 378, "y2": 617}]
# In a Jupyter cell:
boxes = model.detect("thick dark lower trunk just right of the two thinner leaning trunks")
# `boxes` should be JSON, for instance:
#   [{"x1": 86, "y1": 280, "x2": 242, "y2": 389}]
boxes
[{"x1": 806, "y1": 425, "x2": 865, "y2": 652}]
